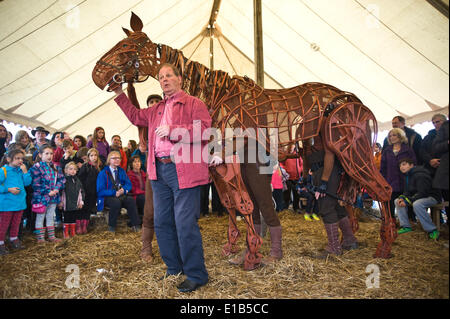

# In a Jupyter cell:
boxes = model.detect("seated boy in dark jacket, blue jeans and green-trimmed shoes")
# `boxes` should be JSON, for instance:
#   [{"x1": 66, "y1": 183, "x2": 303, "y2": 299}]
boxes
[{"x1": 394, "y1": 158, "x2": 441, "y2": 239}]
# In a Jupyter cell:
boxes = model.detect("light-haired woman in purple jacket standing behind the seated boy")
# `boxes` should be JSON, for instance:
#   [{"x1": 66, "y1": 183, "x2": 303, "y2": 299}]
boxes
[{"x1": 380, "y1": 128, "x2": 417, "y2": 217}]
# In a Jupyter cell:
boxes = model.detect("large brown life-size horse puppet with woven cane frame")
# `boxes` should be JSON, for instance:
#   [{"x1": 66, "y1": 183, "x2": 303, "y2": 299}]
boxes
[{"x1": 92, "y1": 13, "x2": 397, "y2": 270}]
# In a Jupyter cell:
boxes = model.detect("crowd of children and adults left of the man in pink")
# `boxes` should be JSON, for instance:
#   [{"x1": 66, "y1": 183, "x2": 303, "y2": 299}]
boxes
[{"x1": 0, "y1": 124, "x2": 154, "y2": 255}]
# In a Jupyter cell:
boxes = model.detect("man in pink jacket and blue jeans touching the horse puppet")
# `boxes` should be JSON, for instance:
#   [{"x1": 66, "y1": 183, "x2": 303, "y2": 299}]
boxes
[{"x1": 114, "y1": 64, "x2": 211, "y2": 292}]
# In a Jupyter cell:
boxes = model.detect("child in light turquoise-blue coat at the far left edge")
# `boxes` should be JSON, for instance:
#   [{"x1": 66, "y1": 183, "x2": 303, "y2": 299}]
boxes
[{"x1": 0, "y1": 149, "x2": 32, "y2": 255}]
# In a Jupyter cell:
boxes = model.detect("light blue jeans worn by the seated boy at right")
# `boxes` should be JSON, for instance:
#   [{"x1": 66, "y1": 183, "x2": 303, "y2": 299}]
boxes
[{"x1": 394, "y1": 196, "x2": 437, "y2": 233}]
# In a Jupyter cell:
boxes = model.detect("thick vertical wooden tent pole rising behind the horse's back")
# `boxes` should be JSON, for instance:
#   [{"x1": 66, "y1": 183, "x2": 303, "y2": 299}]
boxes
[{"x1": 253, "y1": 0, "x2": 264, "y2": 87}]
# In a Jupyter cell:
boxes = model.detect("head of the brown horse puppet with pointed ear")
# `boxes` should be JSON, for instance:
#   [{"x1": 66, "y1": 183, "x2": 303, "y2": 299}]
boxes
[{"x1": 92, "y1": 12, "x2": 159, "y2": 91}]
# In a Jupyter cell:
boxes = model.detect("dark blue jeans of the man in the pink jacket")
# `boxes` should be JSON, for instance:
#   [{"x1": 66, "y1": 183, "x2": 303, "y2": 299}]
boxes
[{"x1": 151, "y1": 161, "x2": 208, "y2": 284}]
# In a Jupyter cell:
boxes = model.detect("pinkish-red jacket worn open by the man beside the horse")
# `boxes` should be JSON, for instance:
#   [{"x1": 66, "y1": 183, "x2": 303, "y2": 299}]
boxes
[{"x1": 114, "y1": 91, "x2": 212, "y2": 189}]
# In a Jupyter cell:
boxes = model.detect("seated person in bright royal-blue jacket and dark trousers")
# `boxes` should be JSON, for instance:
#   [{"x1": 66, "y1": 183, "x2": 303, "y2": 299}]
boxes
[{"x1": 97, "y1": 151, "x2": 140, "y2": 233}]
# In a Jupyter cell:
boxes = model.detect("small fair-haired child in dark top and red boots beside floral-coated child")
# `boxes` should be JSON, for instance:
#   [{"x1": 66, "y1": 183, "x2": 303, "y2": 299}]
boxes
[{"x1": 59, "y1": 162, "x2": 87, "y2": 239}]
